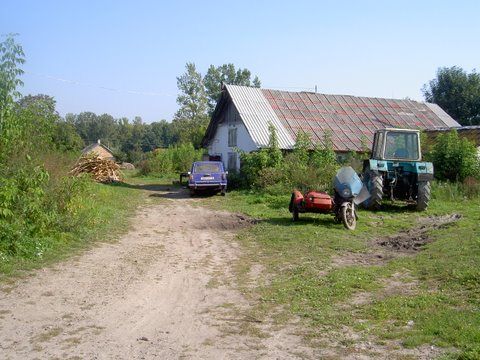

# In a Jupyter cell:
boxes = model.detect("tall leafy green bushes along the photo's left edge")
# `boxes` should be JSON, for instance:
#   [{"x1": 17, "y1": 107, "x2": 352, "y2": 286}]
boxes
[{"x1": 0, "y1": 37, "x2": 114, "y2": 269}]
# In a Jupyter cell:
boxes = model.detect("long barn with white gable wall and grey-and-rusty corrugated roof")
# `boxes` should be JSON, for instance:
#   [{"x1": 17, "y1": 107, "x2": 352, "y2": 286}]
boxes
[{"x1": 202, "y1": 84, "x2": 460, "y2": 170}]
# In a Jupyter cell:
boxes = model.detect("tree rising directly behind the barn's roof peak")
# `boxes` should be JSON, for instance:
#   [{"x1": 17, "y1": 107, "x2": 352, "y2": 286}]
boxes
[{"x1": 203, "y1": 64, "x2": 261, "y2": 115}]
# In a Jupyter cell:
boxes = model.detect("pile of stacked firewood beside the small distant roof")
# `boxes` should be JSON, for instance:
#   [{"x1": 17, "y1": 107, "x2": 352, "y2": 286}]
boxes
[{"x1": 70, "y1": 153, "x2": 122, "y2": 183}]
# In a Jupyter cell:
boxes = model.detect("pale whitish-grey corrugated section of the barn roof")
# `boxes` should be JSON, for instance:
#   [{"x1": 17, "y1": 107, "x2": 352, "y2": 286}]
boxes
[{"x1": 225, "y1": 85, "x2": 295, "y2": 149}]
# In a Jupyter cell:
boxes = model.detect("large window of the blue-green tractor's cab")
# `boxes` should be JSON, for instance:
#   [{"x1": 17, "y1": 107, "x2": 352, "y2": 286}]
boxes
[{"x1": 385, "y1": 132, "x2": 418, "y2": 160}]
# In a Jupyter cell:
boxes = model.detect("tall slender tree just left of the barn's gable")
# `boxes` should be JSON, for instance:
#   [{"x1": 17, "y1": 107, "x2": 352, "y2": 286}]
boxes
[{"x1": 172, "y1": 63, "x2": 208, "y2": 147}]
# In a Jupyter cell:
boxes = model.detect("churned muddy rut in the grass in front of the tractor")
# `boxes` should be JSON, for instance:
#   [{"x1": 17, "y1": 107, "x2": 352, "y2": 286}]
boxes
[{"x1": 377, "y1": 214, "x2": 462, "y2": 252}]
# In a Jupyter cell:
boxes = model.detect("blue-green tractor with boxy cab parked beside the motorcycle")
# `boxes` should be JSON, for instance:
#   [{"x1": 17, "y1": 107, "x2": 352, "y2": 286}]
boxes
[{"x1": 362, "y1": 129, "x2": 433, "y2": 211}]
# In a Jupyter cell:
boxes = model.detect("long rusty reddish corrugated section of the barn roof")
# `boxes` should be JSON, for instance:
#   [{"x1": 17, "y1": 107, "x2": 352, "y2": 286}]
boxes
[{"x1": 261, "y1": 89, "x2": 460, "y2": 151}]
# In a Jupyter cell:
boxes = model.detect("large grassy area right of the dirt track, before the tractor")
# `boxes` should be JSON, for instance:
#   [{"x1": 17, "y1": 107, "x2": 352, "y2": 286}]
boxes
[{"x1": 205, "y1": 185, "x2": 480, "y2": 359}]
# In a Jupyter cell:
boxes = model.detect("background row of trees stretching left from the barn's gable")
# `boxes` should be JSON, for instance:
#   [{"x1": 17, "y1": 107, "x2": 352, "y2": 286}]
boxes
[{"x1": 26, "y1": 63, "x2": 260, "y2": 162}]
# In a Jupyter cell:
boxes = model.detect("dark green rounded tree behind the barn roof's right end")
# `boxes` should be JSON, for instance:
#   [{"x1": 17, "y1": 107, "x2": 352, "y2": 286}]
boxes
[{"x1": 422, "y1": 66, "x2": 480, "y2": 125}]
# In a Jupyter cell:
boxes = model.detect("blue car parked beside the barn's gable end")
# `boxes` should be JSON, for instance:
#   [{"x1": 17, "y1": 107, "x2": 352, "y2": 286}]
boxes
[{"x1": 188, "y1": 161, "x2": 228, "y2": 196}]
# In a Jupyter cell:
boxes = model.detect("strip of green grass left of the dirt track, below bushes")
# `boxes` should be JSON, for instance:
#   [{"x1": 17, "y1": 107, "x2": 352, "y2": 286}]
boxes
[{"x1": 0, "y1": 182, "x2": 144, "y2": 280}]
